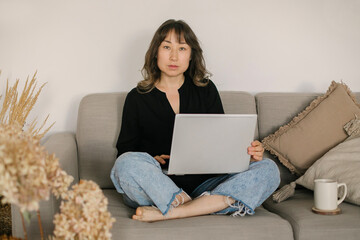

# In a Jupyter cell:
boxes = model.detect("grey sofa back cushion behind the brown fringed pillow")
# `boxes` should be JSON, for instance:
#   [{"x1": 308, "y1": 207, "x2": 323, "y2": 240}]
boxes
[{"x1": 255, "y1": 92, "x2": 360, "y2": 186}]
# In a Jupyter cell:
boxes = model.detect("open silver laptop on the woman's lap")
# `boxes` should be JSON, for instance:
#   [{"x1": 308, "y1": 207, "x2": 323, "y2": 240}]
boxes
[{"x1": 164, "y1": 114, "x2": 257, "y2": 175}]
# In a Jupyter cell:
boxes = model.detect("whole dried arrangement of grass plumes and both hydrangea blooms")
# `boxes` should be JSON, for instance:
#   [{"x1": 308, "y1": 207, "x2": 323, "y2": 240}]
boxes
[{"x1": 0, "y1": 72, "x2": 115, "y2": 239}]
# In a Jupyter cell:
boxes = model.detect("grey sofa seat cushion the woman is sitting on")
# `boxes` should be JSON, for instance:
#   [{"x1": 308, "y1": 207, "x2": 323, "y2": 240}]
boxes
[{"x1": 103, "y1": 189, "x2": 293, "y2": 240}]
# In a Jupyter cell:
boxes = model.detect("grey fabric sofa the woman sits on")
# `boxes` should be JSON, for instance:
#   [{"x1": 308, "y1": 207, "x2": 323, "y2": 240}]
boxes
[{"x1": 12, "y1": 91, "x2": 360, "y2": 240}]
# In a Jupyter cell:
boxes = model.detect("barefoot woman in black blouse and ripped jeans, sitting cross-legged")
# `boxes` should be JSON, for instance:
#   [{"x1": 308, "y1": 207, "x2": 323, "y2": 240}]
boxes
[{"x1": 111, "y1": 20, "x2": 280, "y2": 222}]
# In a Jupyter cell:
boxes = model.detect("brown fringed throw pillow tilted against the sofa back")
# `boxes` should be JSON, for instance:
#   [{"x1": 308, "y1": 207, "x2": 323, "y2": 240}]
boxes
[{"x1": 263, "y1": 81, "x2": 360, "y2": 175}]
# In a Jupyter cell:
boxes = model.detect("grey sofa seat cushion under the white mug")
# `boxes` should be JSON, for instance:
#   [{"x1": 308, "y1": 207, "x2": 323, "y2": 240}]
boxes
[{"x1": 263, "y1": 189, "x2": 360, "y2": 240}]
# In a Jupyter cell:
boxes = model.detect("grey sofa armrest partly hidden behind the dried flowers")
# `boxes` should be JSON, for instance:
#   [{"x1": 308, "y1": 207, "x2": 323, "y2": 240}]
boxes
[{"x1": 11, "y1": 132, "x2": 79, "y2": 239}]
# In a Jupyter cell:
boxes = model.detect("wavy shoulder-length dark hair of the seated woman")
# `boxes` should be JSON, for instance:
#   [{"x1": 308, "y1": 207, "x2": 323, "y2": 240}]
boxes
[{"x1": 137, "y1": 19, "x2": 210, "y2": 93}]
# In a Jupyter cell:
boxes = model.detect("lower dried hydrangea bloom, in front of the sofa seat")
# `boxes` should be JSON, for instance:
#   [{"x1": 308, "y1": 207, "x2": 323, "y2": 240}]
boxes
[{"x1": 54, "y1": 180, "x2": 115, "y2": 239}]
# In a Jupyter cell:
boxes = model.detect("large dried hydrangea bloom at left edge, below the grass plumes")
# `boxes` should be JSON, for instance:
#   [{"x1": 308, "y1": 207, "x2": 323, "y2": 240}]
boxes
[{"x1": 0, "y1": 123, "x2": 73, "y2": 212}]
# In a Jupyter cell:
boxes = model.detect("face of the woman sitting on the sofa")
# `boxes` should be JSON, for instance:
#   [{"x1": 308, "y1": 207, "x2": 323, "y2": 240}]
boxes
[{"x1": 157, "y1": 30, "x2": 191, "y2": 78}]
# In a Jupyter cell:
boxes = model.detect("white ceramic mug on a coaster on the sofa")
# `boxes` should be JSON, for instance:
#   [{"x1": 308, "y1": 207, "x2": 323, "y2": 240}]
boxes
[{"x1": 314, "y1": 179, "x2": 347, "y2": 211}]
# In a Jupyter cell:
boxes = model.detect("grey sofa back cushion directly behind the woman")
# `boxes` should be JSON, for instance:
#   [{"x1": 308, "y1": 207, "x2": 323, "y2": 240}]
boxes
[{"x1": 76, "y1": 91, "x2": 256, "y2": 188}]
